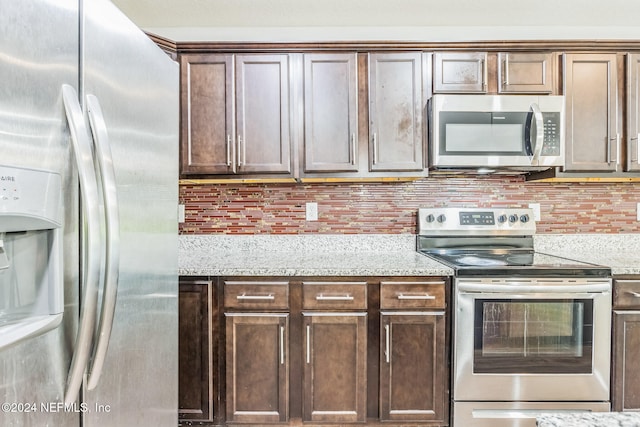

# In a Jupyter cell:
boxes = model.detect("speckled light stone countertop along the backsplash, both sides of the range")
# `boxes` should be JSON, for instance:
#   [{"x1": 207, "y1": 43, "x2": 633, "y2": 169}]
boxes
[{"x1": 178, "y1": 234, "x2": 640, "y2": 276}]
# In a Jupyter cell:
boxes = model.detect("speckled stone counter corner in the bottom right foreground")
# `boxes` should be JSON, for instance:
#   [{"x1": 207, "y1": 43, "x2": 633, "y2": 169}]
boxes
[{"x1": 537, "y1": 412, "x2": 640, "y2": 427}]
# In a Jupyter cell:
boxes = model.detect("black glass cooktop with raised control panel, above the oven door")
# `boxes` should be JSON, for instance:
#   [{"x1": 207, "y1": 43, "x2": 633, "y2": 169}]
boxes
[{"x1": 417, "y1": 208, "x2": 611, "y2": 277}]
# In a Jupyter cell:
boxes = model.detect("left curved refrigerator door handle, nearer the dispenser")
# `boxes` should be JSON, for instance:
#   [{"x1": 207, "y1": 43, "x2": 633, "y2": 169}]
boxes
[{"x1": 62, "y1": 85, "x2": 102, "y2": 405}]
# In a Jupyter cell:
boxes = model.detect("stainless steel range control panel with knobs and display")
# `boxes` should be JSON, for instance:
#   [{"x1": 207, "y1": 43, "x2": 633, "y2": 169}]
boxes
[{"x1": 418, "y1": 208, "x2": 536, "y2": 236}]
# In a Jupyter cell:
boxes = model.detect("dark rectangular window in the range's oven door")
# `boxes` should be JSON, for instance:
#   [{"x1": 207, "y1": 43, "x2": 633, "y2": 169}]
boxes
[{"x1": 473, "y1": 299, "x2": 593, "y2": 374}]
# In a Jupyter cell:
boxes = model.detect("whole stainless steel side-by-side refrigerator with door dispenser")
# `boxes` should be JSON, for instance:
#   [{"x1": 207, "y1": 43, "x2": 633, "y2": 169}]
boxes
[{"x1": 0, "y1": 0, "x2": 179, "y2": 427}]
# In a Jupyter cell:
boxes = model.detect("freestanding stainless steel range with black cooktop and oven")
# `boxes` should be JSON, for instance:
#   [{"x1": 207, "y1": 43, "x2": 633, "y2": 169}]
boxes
[{"x1": 418, "y1": 208, "x2": 611, "y2": 427}]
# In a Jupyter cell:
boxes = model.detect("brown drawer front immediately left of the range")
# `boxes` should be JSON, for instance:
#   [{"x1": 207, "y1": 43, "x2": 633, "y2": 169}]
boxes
[{"x1": 380, "y1": 280, "x2": 446, "y2": 309}]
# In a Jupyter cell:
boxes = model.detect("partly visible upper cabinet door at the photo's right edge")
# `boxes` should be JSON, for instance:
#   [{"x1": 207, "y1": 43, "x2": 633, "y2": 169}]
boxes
[{"x1": 627, "y1": 54, "x2": 640, "y2": 171}]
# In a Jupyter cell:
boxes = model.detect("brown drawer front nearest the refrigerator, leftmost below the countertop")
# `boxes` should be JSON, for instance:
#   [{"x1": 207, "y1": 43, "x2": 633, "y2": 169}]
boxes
[{"x1": 224, "y1": 281, "x2": 289, "y2": 310}]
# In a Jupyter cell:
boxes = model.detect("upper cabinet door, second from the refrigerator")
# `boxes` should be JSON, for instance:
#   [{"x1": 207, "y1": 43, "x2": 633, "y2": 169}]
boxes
[{"x1": 236, "y1": 55, "x2": 291, "y2": 173}]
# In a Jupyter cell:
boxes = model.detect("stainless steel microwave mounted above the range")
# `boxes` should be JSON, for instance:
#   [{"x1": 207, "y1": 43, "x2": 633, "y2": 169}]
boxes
[{"x1": 428, "y1": 95, "x2": 565, "y2": 171}]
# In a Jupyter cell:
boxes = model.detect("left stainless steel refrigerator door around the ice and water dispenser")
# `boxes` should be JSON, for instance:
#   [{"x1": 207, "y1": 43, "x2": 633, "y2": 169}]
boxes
[{"x1": 0, "y1": 0, "x2": 81, "y2": 427}]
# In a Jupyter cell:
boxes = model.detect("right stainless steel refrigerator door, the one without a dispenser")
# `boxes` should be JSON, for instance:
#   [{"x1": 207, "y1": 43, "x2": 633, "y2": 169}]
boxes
[{"x1": 80, "y1": 0, "x2": 179, "y2": 427}]
